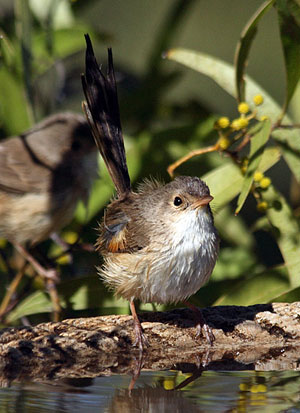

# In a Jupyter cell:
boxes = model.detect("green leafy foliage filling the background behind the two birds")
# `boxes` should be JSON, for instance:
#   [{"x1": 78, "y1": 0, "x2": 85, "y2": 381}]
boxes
[{"x1": 0, "y1": 0, "x2": 300, "y2": 325}]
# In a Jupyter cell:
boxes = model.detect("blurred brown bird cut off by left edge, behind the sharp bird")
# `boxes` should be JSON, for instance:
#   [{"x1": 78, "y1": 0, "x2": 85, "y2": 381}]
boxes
[{"x1": 0, "y1": 112, "x2": 98, "y2": 318}]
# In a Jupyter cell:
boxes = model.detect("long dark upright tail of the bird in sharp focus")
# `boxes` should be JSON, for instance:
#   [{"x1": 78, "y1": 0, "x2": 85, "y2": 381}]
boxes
[{"x1": 81, "y1": 34, "x2": 131, "y2": 197}]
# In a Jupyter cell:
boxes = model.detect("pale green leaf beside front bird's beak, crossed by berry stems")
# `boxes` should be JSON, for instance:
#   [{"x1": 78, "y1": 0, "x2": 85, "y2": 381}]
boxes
[{"x1": 202, "y1": 148, "x2": 280, "y2": 212}]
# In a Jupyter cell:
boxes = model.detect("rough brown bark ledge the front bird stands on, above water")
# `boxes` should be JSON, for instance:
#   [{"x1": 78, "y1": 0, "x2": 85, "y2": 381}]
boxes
[{"x1": 0, "y1": 302, "x2": 300, "y2": 385}]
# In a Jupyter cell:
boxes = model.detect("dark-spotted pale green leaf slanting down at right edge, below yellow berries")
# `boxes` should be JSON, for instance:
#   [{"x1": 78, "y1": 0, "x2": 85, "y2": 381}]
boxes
[{"x1": 262, "y1": 185, "x2": 300, "y2": 287}]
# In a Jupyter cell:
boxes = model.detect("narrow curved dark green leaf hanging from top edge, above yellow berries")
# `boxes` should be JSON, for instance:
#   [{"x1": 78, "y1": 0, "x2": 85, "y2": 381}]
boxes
[{"x1": 234, "y1": 0, "x2": 275, "y2": 102}]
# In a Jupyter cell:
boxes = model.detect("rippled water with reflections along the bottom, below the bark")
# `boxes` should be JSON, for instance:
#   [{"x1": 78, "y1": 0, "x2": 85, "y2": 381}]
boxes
[{"x1": 0, "y1": 371, "x2": 300, "y2": 413}]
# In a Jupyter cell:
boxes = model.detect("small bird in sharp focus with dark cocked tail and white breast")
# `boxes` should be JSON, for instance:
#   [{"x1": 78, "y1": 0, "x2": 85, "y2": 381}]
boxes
[{"x1": 82, "y1": 34, "x2": 219, "y2": 351}]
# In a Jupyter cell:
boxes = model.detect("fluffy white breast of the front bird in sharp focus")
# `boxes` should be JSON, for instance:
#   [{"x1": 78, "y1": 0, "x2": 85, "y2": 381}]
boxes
[{"x1": 145, "y1": 209, "x2": 218, "y2": 303}]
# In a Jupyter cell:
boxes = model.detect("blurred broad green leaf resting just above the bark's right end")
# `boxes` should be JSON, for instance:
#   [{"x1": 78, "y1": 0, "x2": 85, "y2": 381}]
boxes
[{"x1": 214, "y1": 267, "x2": 290, "y2": 305}]
